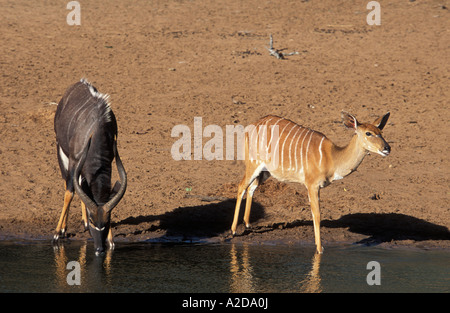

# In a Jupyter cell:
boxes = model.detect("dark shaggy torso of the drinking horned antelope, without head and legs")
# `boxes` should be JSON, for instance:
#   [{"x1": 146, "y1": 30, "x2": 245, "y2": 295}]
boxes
[{"x1": 55, "y1": 79, "x2": 117, "y2": 204}]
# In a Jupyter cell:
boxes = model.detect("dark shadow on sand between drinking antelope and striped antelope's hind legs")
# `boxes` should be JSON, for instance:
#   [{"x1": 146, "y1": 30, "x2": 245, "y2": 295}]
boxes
[{"x1": 112, "y1": 199, "x2": 264, "y2": 239}]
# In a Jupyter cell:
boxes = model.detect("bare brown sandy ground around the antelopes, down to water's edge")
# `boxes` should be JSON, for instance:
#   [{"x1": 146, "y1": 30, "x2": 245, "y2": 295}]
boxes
[{"x1": 0, "y1": 0, "x2": 450, "y2": 248}]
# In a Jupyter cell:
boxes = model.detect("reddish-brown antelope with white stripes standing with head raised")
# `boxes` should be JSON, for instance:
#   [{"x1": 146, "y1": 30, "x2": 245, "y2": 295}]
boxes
[{"x1": 231, "y1": 112, "x2": 391, "y2": 253}]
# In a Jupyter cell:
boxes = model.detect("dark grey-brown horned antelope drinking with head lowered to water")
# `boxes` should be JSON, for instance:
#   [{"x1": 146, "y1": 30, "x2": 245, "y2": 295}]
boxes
[{"x1": 53, "y1": 79, "x2": 127, "y2": 254}]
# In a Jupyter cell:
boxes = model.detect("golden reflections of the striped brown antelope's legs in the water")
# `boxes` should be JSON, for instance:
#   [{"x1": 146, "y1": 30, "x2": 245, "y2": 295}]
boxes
[{"x1": 230, "y1": 243, "x2": 322, "y2": 293}]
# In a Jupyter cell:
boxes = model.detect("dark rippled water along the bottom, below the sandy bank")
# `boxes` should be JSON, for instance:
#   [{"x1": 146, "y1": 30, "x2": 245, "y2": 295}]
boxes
[{"x1": 0, "y1": 241, "x2": 450, "y2": 293}]
